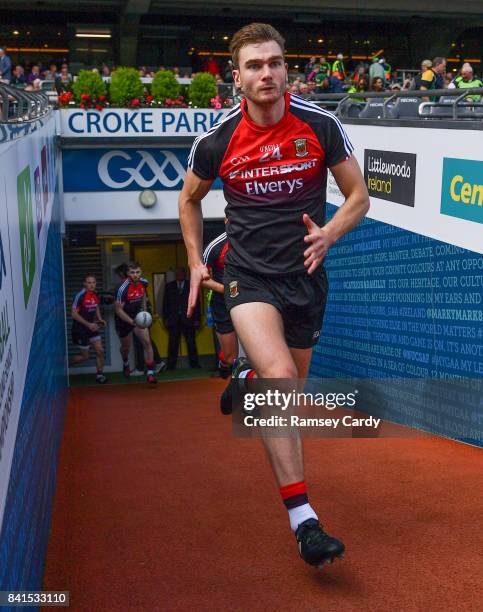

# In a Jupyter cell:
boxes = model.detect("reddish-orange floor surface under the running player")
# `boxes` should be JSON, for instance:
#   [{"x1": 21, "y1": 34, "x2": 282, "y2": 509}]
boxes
[{"x1": 44, "y1": 380, "x2": 483, "y2": 612}]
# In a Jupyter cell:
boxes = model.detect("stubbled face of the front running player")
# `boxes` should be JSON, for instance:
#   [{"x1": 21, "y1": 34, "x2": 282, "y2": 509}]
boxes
[{"x1": 233, "y1": 40, "x2": 287, "y2": 106}]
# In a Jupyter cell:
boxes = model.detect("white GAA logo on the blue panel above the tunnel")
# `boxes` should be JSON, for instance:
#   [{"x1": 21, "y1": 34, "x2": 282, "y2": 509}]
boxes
[{"x1": 97, "y1": 150, "x2": 186, "y2": 189}]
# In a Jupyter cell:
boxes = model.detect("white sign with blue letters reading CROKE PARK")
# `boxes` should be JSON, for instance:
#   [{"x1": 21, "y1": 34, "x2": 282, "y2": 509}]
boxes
[{"x1": 60, "y1": 108, "x2": 233, "y2": 138}]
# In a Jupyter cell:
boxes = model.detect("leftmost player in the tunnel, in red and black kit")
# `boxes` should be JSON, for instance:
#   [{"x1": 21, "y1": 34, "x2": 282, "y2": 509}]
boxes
[{"x1": 71, "y1": 274, "x2": 107, "y2": 385}]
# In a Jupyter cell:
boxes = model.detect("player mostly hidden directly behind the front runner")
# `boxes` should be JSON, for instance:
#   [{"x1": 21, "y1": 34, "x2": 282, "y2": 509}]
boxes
[{"x1": 203, "y1": 227, "x2": 238, "y2": 384}]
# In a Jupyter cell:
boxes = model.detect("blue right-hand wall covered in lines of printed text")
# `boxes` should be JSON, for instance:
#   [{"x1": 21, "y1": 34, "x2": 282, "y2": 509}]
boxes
[{"x1": 310, "y1": 205, "x2": 483, "y2": 445}]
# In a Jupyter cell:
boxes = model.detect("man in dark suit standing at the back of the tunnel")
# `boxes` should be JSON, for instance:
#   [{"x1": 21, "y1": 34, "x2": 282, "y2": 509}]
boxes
[{"x1": 163, "y1": 268, "x2": 200, "y2": 370}]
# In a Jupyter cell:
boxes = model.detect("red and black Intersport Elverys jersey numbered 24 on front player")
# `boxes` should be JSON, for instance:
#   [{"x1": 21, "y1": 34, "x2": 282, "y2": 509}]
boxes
[{"x1": 188, "y1": 93, "x2": 354, "y2": 275}]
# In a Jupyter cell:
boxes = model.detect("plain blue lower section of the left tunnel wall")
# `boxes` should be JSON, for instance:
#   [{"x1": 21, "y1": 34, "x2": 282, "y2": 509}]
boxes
[{"x1": 0, "y1": 194, "x2": 67, "y2": 590}]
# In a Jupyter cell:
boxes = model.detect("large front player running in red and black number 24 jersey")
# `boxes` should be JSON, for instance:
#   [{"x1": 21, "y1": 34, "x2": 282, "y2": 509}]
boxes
[{"x1": 179, "y1": 24, "x2": 369, "y2": 566}]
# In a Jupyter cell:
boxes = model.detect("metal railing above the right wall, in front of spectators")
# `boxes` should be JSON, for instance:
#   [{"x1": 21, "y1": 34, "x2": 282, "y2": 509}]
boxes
[{"x1": 303, "y1": 87, "x2": 483, "y2": 121}]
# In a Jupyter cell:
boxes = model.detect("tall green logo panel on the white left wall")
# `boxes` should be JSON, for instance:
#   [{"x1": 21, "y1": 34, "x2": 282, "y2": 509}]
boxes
[{"x1": 17, "y1": 166, "x2": 35, "y2": 308}]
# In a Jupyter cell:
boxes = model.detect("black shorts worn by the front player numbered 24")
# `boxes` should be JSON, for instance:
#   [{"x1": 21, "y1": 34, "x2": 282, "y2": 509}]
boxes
[{"x1": 223, "y1": 265, "x2": 329, "y2": 348}]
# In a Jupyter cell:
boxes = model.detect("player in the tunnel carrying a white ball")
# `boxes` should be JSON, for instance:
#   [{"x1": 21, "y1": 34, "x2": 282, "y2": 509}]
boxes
[{"x1": 115, "y1": 261, "x2": 157, "y2": 385}]
